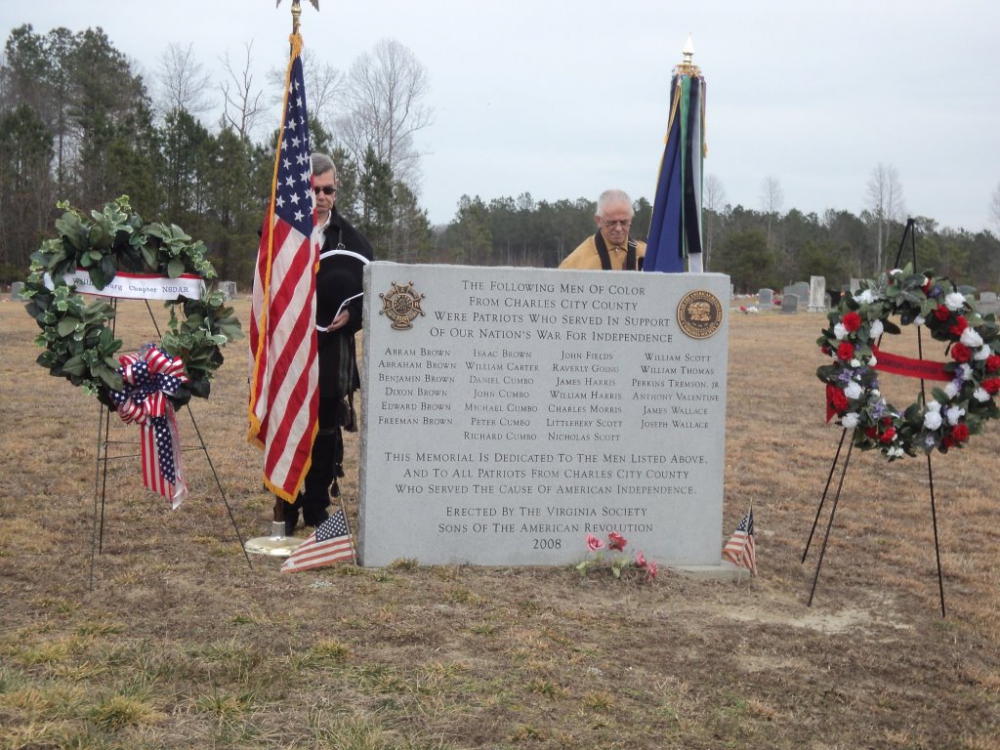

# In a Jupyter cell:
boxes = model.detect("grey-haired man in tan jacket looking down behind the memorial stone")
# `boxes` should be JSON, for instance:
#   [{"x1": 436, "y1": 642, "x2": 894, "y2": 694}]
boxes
[{"x1": 559, "y1": 190, "x2": 646, "y2": 271}]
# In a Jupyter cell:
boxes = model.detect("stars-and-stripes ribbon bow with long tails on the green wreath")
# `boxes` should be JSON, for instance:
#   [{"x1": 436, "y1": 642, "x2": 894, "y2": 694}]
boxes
[{"x1": 111, "y1": 344, "x2": 188, "y2": 508}]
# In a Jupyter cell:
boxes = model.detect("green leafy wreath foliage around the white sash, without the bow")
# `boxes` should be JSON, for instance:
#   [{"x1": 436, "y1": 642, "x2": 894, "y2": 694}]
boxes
[{"x1": 23, "y1": 196, "x2": 243, "y2": 407}]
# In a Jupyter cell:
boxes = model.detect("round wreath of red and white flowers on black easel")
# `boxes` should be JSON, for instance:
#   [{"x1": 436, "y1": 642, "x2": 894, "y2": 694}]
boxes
[{"x1": 816, "y1": 265, "x2": 1000, "y2": 461}]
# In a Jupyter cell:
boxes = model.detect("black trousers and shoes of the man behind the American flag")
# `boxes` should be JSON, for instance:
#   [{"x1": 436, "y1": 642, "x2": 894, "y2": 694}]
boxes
[{"x1": 284, "y1": 398, "x2": 344, "y2": 533}]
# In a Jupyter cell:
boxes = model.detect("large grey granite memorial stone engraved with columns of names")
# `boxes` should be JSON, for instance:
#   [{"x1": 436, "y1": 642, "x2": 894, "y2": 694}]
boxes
[{"x1": 359, "y1": 263, "x2": 729, "y2": 566}]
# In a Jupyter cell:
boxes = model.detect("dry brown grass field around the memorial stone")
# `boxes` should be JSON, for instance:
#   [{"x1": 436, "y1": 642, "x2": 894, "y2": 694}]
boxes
[{"x1": 0, "y1": 301, "x2": 1000, "y2": 750}]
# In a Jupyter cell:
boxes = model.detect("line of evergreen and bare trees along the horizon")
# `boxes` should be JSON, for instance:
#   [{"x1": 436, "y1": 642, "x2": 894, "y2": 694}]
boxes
[{"x1": 0, "y1": 24, "x2": 1000, "y2": 293}]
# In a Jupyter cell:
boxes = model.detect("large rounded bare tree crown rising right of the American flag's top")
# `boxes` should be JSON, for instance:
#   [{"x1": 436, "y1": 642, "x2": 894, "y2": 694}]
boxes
[{"x1": 337, "y1": 39, "x2": 432, "y2": 186}]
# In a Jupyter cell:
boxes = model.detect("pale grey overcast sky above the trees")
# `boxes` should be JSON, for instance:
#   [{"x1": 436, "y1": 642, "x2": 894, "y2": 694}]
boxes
[{"x1": 7, "y1": 0, "x2": 1000, "y2": 231}]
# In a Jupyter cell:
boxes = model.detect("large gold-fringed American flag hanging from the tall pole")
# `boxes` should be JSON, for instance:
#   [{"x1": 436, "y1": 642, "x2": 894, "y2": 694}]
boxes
[{"x1": 247, "y1": 29, "x2": 319, "y2": 502}]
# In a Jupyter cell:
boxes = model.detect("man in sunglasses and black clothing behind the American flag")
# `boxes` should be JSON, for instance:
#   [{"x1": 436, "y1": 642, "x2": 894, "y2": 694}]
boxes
[{"x1": 284, "y1": 154, "x2": 373, "y2": 536}]
